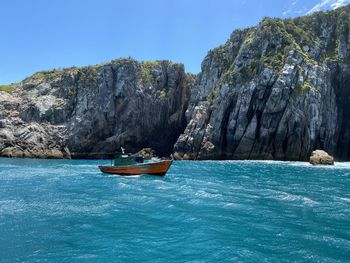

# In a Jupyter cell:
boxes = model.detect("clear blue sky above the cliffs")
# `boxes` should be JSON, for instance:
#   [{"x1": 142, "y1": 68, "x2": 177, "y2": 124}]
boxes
[{"x1": 0, "y1": 0, "x2": 350, "y2": 85}]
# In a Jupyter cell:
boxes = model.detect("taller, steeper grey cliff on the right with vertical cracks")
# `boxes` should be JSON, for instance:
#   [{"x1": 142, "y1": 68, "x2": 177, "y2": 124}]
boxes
[{"x1": 174, "y1": 6, "x2": 350, "y2": 160}]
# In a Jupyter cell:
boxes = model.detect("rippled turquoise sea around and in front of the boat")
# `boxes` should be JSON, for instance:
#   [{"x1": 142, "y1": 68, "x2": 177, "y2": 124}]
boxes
[{"x1": 0, "y1": 158, "x2": 350, "y2": 262}]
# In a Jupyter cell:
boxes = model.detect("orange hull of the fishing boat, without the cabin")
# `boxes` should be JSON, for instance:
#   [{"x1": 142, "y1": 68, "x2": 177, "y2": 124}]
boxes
[{"x1": 98, "y1": 160, "x2": 173, "y2": 176}]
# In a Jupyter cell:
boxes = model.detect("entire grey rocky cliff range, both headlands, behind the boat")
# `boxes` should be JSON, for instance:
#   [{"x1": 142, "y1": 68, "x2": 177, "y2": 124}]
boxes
[{"x1": 0, "y1": 6, "x2": 350, "y2": 160}]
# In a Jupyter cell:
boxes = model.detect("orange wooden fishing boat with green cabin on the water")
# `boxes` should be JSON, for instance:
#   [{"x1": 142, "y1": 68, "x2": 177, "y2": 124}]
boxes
[{"x1": 98, "y1": 151, "x2": 173, "y2": 176}]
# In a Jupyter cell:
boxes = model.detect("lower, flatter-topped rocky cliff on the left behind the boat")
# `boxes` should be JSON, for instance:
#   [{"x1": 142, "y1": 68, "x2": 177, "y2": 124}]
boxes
[{"x1": 0, "y1": 59, "x2": 194, "y2": 158}]
